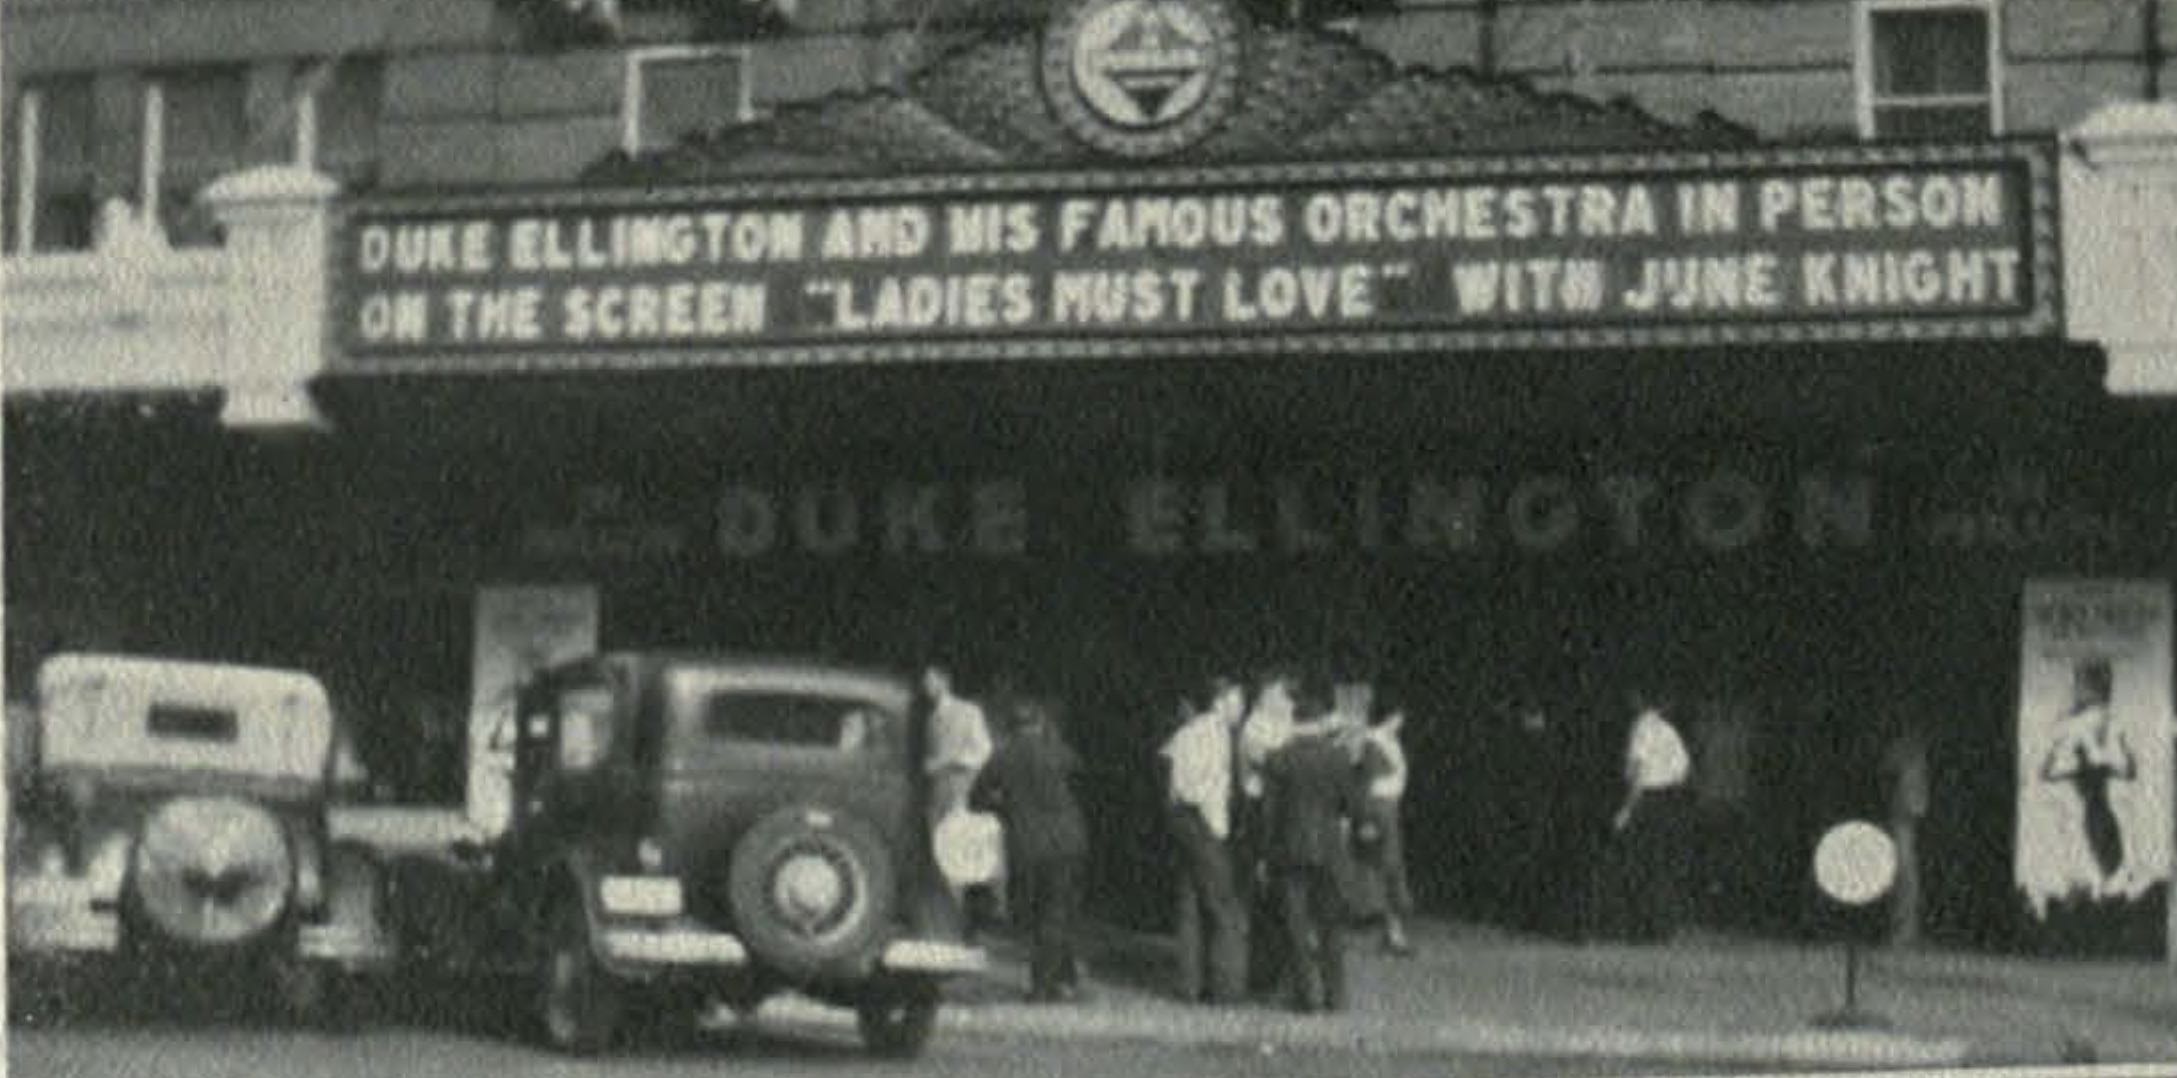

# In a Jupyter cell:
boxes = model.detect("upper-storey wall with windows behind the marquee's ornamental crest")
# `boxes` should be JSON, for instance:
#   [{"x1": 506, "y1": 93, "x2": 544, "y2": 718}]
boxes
[{"x1": 12, "y1": 0, "x2": 2177, "y2": 250}]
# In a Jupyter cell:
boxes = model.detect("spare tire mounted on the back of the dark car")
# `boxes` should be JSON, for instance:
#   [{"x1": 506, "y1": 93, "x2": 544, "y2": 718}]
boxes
[{"x1": 727, "y1": 806, "x2": 899, "y2": 982}]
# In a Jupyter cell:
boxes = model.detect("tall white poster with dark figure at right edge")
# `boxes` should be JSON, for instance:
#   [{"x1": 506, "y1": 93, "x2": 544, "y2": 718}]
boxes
[{"x1": 2014, "y1": 579, "x2": 2173, "y2": 950}]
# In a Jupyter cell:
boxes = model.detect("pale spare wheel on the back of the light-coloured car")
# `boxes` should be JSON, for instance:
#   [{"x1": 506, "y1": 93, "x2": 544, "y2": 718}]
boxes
[{"x1": 131, "y1": 797, "x2": 294, "y2": 947}]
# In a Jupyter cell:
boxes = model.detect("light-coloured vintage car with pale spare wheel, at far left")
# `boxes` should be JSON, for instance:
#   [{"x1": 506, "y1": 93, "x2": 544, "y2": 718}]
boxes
[{"x1": 7, "y1": 653, "x2": 390, "y2": 1019}]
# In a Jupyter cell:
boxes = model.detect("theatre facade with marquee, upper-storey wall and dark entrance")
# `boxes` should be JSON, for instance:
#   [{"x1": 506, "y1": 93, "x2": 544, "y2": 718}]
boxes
[{"x1": 4, "y1": 0, "x2": 2177, "y2": 950}]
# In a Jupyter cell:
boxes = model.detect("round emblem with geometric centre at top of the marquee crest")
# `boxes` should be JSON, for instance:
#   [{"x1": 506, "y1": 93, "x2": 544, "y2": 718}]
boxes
[{"x1": 1043, "y1": 0, "x2": 1239, "y2": 157}]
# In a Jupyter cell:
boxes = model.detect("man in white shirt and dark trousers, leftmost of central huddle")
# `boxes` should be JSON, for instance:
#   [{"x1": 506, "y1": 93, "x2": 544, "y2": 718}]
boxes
[{"x1": 1158, "y1": 677, "x2": 1247, "y2": 1004}]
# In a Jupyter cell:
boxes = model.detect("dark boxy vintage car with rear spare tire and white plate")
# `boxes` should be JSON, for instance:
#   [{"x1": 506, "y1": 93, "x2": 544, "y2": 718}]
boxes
[{"x1": 390, "y1": 653, "x2": 997, "y2": 1056}]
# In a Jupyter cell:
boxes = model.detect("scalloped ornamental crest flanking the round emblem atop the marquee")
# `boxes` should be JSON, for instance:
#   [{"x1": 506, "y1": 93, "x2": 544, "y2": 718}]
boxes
[{"x1": 583, "y1": 24, "x2": 1755, "y2": 185}]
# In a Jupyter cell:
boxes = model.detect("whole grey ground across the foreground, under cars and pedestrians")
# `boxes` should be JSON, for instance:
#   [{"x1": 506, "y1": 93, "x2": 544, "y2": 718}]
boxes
[{"x1": 9, "y1": 923, "x2": 2177, "y2": 1078}]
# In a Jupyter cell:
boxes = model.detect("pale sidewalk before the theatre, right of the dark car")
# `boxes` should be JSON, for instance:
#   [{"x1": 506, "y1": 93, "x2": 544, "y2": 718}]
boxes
[{"x1": 775, "y1": 923, "x2": 2177, "y2": 1067}]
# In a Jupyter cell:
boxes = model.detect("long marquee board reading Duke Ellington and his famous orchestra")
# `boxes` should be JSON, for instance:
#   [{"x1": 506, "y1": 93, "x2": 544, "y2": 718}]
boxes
[{"x1": 333, "y1": 142, "x2": 2059, "y2": 370}]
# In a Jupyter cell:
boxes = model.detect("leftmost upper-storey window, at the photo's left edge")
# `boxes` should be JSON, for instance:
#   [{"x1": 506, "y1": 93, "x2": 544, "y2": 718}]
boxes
[{"x1": 0, "y1": 76, "x2": 96, "y2": 253}]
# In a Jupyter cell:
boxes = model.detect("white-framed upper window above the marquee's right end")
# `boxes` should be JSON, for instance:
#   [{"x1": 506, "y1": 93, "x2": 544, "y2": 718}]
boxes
[{"x1": 1855, "y1": 0, "x2": 2003, "y2": 139}]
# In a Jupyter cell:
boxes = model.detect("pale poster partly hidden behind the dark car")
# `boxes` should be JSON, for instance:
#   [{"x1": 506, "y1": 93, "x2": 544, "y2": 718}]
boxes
[{"x1": 468, "y1": 584, "x2": 599, "y2": 834}]
